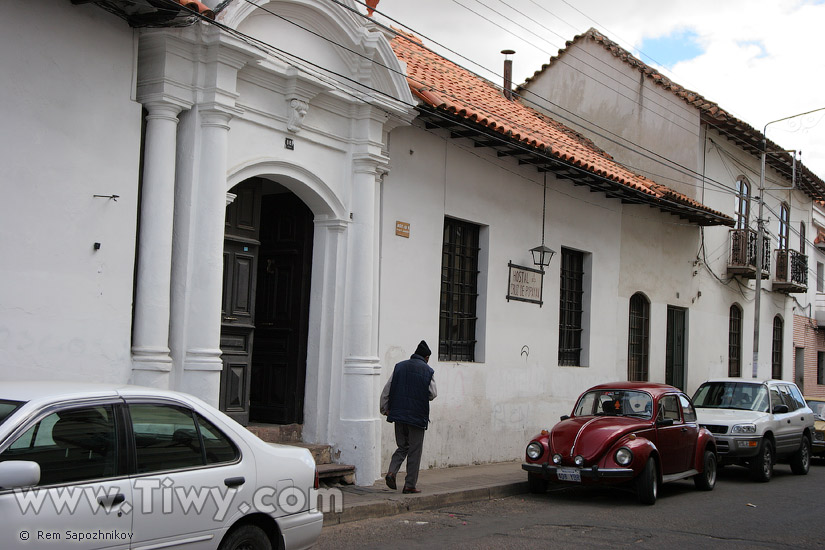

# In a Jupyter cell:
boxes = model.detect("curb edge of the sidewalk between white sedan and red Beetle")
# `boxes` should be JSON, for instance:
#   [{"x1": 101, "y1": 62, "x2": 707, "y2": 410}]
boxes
[{"x1": 324, "y1": 481, "x2": 529, "y2": 526}]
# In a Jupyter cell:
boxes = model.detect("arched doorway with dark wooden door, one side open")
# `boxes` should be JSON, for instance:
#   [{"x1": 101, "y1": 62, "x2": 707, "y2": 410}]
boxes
[{"x1": 221, "y1": 178, "x2": 313, "y2": 424}]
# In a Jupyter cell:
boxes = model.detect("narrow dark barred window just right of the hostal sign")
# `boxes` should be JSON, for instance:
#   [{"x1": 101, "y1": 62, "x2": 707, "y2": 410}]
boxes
[{"x1": 559, "y1": 248, "x2": 584, "y2": 366}]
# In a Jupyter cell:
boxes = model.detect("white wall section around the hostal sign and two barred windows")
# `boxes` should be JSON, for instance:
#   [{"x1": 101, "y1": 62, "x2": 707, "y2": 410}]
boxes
[{"x1": 376, "y1": 123, "x2": 636, "y2": 467}]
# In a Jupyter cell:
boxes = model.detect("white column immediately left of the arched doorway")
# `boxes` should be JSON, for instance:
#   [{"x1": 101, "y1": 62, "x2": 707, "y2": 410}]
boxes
[{"x1": 182, "y1": 108, "x2": 232, "y2": 405}]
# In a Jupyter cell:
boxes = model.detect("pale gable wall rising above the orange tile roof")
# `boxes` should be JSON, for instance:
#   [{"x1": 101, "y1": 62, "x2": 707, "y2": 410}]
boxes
[{"x1": 523, "y1": 40, "x2": 702, "y2": 198}]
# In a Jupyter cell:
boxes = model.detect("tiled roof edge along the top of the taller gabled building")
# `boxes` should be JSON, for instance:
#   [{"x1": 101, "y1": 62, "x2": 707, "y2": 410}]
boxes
[{"x1": 516, "y1": 28, "x2": 825, "y2": 200}]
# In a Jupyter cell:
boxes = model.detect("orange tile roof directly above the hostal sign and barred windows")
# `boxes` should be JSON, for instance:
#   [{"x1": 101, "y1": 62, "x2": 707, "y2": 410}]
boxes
[{"x1": 392, "y1": 31, "x2": 733, "y2": 225}]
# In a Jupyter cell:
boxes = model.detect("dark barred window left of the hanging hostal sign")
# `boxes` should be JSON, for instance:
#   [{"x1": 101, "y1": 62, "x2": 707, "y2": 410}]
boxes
[{"x1": 438, "y1": 218, "x2": 479, "y2": 361}]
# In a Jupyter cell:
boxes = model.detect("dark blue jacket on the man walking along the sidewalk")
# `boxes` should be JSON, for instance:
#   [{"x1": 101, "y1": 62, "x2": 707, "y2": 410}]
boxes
[{"x1": 387, "y1": 354, "x2": 434, "y2": 430}]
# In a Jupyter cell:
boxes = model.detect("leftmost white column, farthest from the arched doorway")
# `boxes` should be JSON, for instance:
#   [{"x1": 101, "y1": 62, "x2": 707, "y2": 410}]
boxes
[{"x1": 131, "y1": 101, "x2": 181, "y2": 388}]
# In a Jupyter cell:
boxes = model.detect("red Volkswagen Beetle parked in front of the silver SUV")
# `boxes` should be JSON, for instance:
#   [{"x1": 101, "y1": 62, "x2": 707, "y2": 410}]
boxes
[{"x1": 522, "y1": 382, "x2": 716, "y2": 504}]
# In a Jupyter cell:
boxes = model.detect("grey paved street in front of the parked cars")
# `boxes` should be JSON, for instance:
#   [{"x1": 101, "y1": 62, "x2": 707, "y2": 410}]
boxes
[{"x1": 316, "y1": 460, "x2": 825, "y2": 550}]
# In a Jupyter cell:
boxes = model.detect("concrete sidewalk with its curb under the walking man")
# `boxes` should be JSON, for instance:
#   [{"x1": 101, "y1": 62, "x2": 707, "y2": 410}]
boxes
[{"x1": 324, "y1": 462, "x2": 528, "y2": 525}]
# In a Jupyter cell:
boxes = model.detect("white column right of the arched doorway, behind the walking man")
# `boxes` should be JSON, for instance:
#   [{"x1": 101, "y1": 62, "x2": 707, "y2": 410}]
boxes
[{"x1": 340, "y1": 154, "x2": 381, "y2": 485}]
